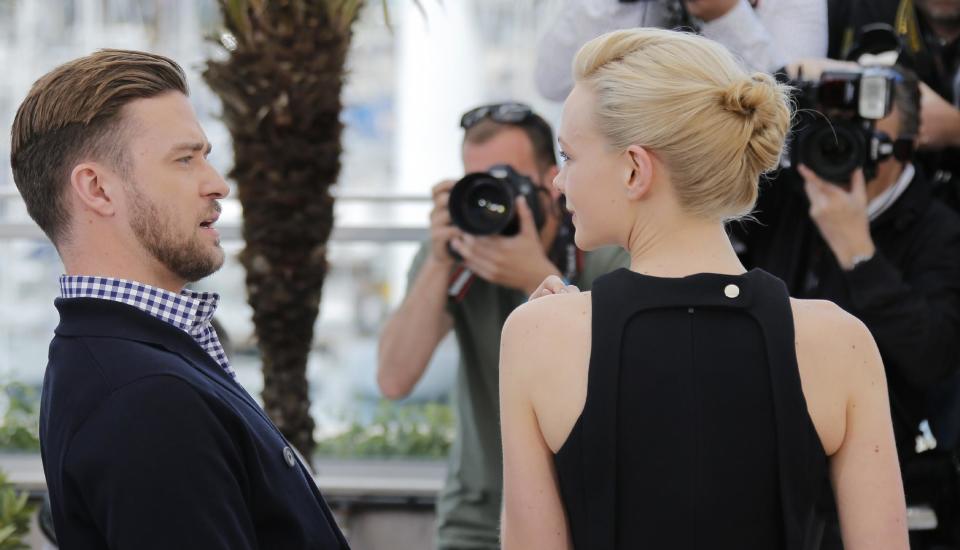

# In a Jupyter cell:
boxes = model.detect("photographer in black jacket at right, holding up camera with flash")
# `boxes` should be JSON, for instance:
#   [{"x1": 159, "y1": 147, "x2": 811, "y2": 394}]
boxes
[{"x1": 731, "y1": 70, "x2": 960, "y2": 548}]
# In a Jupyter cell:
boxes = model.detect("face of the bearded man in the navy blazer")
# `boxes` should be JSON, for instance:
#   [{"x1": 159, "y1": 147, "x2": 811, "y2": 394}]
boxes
[{"x1": 115, "y1": 92, "x2": 229, "y2": 282}]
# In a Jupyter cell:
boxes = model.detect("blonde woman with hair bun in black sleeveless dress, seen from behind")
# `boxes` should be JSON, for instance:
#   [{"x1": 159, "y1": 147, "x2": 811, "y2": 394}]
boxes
[{"x1": 500, "y1": 29, "x2": 907, "y2": 550}]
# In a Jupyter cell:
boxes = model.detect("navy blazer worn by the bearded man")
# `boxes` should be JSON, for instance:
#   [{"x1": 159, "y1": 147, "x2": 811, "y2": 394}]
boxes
[{"x1": 40, "y1": 298, "x2": 348, "y2": 550}]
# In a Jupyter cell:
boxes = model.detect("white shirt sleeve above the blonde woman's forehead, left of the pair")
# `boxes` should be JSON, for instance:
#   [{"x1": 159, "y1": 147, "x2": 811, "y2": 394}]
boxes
[{"x1": 534, "y1": 0, "x2": 663, "y2": 101}]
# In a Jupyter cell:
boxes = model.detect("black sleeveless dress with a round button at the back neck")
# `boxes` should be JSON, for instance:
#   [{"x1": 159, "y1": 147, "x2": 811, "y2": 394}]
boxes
[{"x1": 554, "y1": 269, "x2": 827, "y2": 550}]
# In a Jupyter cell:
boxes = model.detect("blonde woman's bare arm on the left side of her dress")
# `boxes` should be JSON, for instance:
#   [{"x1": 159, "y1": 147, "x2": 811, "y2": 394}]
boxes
[{"x1": 500, "y1": 304, "x2": 573, "y2": 550}]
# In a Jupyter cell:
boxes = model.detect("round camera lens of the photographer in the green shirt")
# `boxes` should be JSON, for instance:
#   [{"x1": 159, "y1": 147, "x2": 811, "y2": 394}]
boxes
[{"x1": 450, "y1": 174, "x2": 514, "y2": 235}]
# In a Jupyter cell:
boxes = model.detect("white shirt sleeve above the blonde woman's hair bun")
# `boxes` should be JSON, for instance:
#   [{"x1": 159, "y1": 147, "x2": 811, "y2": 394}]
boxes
[{"x1": 702, "y1": 0, "x2": 827, "y2": 72}]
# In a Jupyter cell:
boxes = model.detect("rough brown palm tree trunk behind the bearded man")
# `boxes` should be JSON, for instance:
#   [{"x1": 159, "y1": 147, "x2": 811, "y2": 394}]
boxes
[{"x1": 203, "y1": 0, "x2": 362, "y2": 457}]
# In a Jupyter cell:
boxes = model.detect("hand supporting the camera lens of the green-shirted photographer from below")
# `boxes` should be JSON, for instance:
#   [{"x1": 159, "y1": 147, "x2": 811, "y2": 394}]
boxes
[{"x1": 450, "y1": 198, "x2": 560, "y2": 294}]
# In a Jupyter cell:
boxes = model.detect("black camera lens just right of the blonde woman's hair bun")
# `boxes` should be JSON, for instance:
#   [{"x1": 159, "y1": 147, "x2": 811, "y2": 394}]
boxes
[{"x1": 799, "y1": 121, "x2": 866, "y2": 182}]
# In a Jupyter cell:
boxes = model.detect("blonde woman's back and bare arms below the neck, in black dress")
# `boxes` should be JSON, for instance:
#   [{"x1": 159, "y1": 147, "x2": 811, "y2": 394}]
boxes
[{"x1": 500, "y1": 270, "x2": 905, "y2": 550}]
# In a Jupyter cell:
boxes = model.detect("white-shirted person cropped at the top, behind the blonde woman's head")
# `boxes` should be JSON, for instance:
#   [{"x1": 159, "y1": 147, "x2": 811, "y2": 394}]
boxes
[{"x1": 535, "y1": 0, "x2": 827, "y2": 101}]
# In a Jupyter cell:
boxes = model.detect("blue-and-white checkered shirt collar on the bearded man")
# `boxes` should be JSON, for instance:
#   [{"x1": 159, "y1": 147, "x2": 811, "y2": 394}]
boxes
[{"x1": 60, "y1": 275, "x2": 237, "y2": 378}]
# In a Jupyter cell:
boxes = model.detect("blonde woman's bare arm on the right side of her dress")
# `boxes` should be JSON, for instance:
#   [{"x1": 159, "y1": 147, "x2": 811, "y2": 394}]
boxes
[{"x1": 830, "y1": 314, "x2": 910, "y2": 550}]
